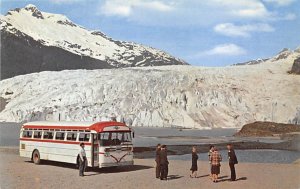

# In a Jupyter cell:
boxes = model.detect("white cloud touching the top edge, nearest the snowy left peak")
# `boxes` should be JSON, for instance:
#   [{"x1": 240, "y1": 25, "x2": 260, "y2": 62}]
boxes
[{"x1": 100, "y1": 0, "x2": 172, "y2": 17}]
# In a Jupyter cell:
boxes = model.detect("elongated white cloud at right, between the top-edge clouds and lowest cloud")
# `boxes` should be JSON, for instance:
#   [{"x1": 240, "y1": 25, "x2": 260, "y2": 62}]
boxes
[{"x1": 214, "y1": 23, "x2": 275, "y2": 37}]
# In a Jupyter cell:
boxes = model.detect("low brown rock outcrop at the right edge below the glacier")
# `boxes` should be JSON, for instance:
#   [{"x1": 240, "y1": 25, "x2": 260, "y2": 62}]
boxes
[{"x1": 235, "y1": 121, "x2": 300, "y2": 137}]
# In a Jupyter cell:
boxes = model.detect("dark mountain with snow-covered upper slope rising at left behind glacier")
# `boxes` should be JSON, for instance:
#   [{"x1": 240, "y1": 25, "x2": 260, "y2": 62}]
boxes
[{"x1": 0, "y1": 5, "x2": 187, "y2": 78}]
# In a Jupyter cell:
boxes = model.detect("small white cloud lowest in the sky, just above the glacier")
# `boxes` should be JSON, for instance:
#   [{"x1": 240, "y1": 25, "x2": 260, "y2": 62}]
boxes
[{"x1": 200, "y1": 43, "x2": 247, "y2": 56}]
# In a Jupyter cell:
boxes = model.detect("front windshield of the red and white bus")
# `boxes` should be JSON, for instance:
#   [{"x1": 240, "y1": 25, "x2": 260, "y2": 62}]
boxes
[{"x1": 98, "y1": 132, "x2": 132, "y2": 146}]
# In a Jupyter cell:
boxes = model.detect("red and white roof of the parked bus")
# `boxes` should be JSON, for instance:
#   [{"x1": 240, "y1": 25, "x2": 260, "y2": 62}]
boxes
[{"x1": 23, "y1": 121, "x2": 130, "y2": 132}]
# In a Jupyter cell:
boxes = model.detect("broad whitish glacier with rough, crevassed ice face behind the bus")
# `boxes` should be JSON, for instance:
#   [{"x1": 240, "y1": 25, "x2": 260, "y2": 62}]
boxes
[{"x1": 0, "y1": 50, "x2": 300, "y2": 128}]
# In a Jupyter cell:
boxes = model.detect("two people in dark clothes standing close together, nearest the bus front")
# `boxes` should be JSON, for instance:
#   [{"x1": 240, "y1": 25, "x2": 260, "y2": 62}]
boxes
[{"x1": 155, "y1": 144, "x2": 169, "y2": 180}]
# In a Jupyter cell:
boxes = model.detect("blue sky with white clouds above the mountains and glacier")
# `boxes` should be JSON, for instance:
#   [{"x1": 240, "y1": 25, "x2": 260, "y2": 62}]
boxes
[{"x1": 0, "y1": 0, "x2": 300, "y2": 66}]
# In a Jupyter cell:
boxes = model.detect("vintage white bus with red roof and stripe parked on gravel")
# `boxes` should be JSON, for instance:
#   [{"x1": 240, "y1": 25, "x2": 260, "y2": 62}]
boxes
[{"x1": 19, "y1": 121, "x2": 133, "y2": 168}]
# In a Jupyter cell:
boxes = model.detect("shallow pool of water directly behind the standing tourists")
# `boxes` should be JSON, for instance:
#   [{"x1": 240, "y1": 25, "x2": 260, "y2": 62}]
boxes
[{"x1": 168, "y1": 150, "x2": 300, "y2": 163}]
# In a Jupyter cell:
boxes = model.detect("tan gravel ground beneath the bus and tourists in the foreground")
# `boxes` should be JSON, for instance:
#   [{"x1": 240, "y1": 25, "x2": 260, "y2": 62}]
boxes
[{"x1": 0, "y1": 148, "x2": 300, "y2": 189}]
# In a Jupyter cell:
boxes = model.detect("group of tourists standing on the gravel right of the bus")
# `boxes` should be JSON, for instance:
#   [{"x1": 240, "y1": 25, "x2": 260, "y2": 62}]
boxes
[{"x1": 155, "y1": 144, "x2": 238, "y2": 183}]
